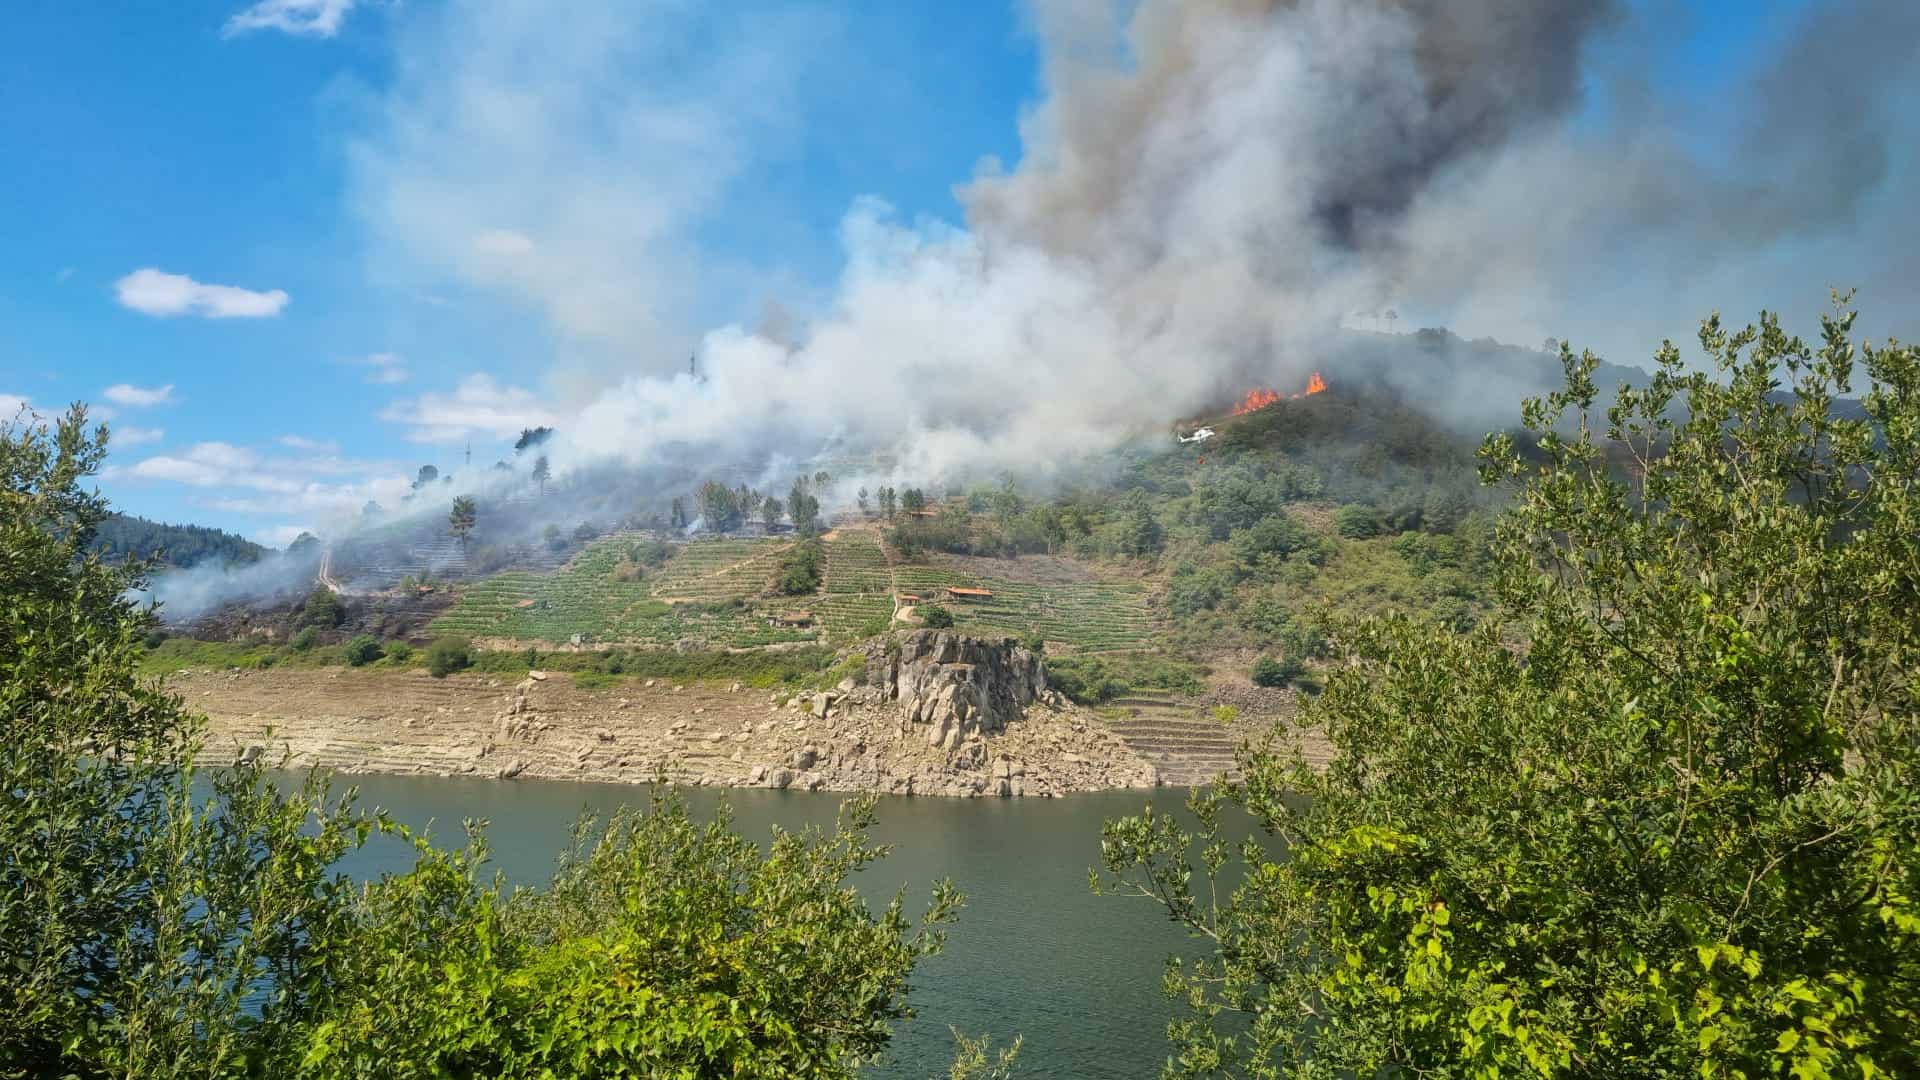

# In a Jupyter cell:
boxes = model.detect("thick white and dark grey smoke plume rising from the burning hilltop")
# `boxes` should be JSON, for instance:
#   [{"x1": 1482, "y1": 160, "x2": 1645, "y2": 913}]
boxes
[{"x1": 522, "y1": 0, "x2": 1920, "y2": 479}]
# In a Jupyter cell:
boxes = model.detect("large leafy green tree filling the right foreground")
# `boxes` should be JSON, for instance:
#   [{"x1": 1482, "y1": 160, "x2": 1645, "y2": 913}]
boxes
[{"x1": 1100, "y1": 297, "x2": 1920, "y2": 1078}]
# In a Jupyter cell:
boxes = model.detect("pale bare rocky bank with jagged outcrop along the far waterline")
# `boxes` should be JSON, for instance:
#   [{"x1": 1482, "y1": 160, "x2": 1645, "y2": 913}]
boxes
[{"x1": 180, "y1": 630, "x2": 1162, "y2": 798}]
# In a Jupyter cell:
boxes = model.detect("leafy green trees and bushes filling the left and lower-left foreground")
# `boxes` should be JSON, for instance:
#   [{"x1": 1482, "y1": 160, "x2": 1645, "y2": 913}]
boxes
[{"x1": 0, "y1": 407, "x2": 958, "y2": 1078}]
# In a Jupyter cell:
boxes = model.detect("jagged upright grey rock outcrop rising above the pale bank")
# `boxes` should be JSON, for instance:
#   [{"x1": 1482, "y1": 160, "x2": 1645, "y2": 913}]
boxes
[{"x1": 866, "y1": 630, "x2": 1052, "y2": 751}]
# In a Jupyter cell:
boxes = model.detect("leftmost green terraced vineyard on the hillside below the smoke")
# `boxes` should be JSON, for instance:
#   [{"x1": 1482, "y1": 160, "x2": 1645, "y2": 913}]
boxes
[{"x1": 430, "y1": 532, "x2": 814, "y2": 648}]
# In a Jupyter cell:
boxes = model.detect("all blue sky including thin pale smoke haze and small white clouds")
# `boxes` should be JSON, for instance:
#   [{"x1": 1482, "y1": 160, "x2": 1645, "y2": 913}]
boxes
[{"x1": 0, "y1": 0, "x2": 1889, "y2": 544}]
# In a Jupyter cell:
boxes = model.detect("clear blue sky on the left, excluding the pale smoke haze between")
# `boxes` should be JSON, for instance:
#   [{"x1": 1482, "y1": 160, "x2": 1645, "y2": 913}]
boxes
[{"x1": 0, "y1": 0, "x2": 1035, "y2": 542}]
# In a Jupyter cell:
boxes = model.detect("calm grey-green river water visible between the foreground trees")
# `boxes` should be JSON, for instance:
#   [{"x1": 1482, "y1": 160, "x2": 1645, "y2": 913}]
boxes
[{"x1": 326, "y1": 776, "x2": 1244, "y2": 1078}]
